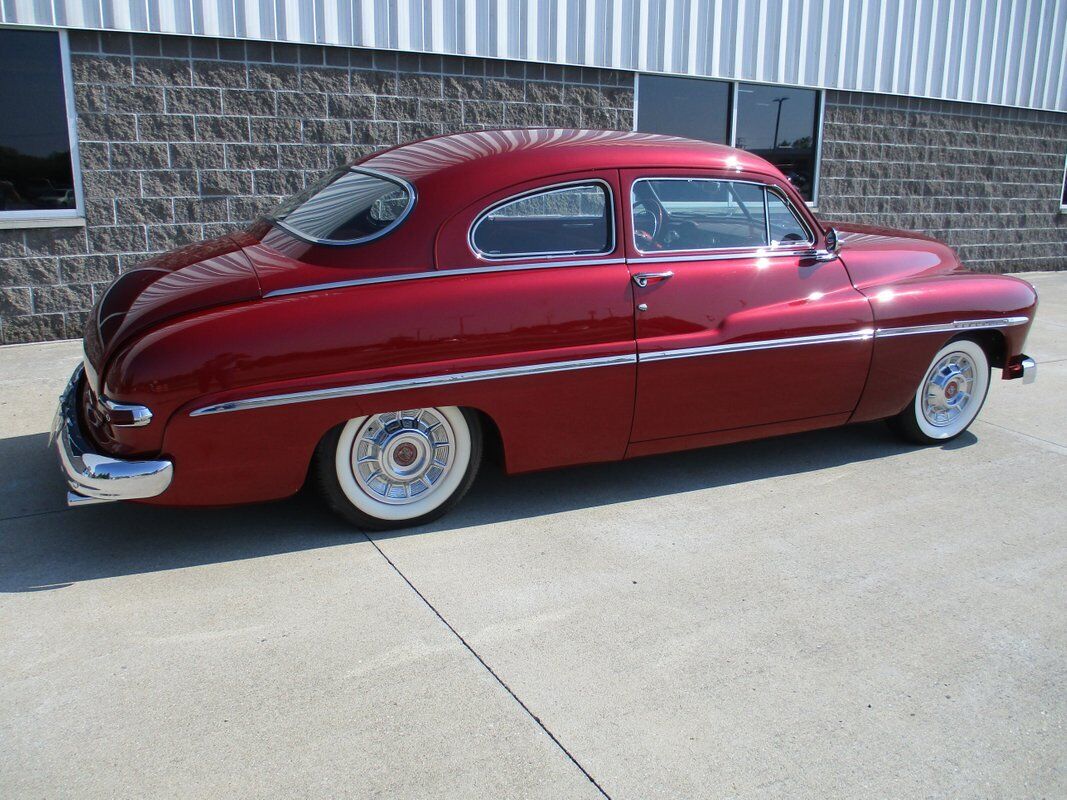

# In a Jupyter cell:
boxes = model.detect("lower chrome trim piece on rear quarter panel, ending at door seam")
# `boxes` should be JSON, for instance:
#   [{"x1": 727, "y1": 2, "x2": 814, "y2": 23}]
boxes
[{"x1": 189, "y1": 353, "x2": 637, "y2": 417}]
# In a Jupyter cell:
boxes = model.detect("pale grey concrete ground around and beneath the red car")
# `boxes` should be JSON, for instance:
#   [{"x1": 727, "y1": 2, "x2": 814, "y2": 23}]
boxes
[{"x1": 0, "y1": 273, "x2": 1067, "y2": 799}]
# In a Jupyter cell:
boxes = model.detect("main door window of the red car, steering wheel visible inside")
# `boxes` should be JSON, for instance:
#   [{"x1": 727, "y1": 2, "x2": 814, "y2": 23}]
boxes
[{"x1": 632, "y1": 178, "x2": 767, "y2": 252}]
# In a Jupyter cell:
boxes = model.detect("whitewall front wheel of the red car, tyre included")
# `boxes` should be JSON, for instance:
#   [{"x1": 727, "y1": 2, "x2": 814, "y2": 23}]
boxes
[{"x1": 889, "y1": 339, "x2": 989, "y2": 445}]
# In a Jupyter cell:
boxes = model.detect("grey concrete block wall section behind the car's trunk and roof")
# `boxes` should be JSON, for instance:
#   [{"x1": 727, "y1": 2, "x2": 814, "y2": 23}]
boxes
[{"x1": 0, "y1": 32, "x2": 634, "y2": 343}]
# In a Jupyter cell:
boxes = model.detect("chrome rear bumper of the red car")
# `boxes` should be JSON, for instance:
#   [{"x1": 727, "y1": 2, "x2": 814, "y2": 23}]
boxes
[{"x1": 49, "y1": 365, "x2": 174, "y2": 506}]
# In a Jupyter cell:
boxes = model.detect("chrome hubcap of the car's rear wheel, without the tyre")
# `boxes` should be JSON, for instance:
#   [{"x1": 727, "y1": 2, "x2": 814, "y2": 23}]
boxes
[{"x1": 352, "y1": 409, "x2": 456, "y2": 506}]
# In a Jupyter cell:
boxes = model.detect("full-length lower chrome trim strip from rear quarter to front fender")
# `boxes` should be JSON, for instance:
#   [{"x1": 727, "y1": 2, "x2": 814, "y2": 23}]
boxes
[{"x1": 189, "y1": 317, "x2": 1029, "y2": 417}]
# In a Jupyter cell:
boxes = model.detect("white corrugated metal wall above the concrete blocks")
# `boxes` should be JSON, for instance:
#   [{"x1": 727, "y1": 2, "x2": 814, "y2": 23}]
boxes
[{"x1": 6, "y1": 0, "x2": 1067, "y2": 111}]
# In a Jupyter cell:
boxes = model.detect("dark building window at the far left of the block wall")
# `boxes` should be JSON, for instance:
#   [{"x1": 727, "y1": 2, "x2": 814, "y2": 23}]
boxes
[{"x1": 0, "y1": 30, "x2": 76, "y2": 212}]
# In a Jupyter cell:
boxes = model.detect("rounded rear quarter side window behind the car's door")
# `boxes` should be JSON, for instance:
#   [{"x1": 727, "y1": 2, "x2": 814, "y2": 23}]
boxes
[{"x1": 471, "y1": 182, "x2": 615, "y2": 258}]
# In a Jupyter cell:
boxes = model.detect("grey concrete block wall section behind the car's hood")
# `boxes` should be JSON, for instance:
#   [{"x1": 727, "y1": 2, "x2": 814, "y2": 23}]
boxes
[{"x1": 818, "y1": 92, "x2": 1067, "y2": 272}]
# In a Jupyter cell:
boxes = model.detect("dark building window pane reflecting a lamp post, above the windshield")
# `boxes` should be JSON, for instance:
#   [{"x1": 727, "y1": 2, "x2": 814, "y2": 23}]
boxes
[{"x1": 734, "y1": 83, "x2": 818, "y2": 201}]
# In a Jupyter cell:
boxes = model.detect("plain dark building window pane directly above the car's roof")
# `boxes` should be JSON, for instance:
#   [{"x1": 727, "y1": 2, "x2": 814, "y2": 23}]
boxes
[{"x1": 637, "y1": 75, "x2": 730, "y2": 144}]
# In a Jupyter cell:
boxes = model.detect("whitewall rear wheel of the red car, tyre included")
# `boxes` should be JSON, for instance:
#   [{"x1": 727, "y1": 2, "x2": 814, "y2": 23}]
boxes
[{"x1": 315, "y1": 406, "x2": 481, "y2": 530}]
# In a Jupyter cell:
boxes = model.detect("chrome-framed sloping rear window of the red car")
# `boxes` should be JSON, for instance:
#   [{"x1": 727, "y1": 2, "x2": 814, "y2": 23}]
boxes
[{"x1": 271, "y1": 167, "x2": 415, "y2": 244}]
